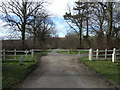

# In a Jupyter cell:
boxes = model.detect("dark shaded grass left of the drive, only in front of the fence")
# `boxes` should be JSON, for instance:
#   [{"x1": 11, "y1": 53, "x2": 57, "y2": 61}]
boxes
[{"x1": 2, "y1": 61, "x2": 37, "y2": 88}]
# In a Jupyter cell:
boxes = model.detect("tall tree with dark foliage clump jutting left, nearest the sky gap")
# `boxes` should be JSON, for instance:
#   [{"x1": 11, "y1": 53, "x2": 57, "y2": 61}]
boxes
[{"x1": 64, "y1": 1, "x2": 86, "y2": 48}]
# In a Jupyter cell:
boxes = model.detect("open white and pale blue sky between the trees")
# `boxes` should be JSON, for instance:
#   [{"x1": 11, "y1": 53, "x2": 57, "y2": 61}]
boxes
[{"x1": 0, "y1": 0, "x2": 75, "y2": 38}]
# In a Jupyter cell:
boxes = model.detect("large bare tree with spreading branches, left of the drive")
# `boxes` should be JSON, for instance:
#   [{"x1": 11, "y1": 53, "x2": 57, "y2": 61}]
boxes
[{"x1": 0, "y1": 0, "x2": 44, "y2": 48}]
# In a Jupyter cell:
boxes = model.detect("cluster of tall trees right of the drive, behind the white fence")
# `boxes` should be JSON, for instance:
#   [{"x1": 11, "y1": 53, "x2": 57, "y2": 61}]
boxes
[{"x1": 63, "y1": 0, "x2": 120, "y2": 48}]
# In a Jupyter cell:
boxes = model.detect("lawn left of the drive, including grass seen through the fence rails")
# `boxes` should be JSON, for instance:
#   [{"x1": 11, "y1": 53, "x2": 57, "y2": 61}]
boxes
[{"x1": 2, "y1": 51, "x2": 48, "y2": 89}]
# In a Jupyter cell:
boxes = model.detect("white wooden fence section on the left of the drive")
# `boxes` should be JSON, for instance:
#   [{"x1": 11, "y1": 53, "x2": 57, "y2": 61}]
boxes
[{"x1": 0, "y1": 49, "x2": 45, "y2": 64}]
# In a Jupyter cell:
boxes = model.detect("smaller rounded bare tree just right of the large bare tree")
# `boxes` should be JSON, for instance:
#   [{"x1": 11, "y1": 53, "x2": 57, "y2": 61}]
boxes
[{"x1": 28, "y1": 12, "x2": 55, "y2": 45}]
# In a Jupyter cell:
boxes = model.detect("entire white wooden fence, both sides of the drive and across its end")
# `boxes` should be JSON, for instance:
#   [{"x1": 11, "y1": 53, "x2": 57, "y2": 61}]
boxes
[{"x1": 0, "y1": 48, "x2": 120, "y2": 63}]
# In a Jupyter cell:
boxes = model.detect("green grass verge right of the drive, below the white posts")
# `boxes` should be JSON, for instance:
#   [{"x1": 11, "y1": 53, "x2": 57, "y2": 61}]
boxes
[{"x1": 78, "y1": 57, "x2": 120, "y2": 85}]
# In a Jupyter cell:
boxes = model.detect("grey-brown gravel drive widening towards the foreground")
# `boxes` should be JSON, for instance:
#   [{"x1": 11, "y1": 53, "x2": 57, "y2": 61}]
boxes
[{"x1": 19, "y1": 51, "x2": 113, "y2": 88}]
